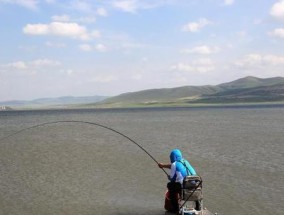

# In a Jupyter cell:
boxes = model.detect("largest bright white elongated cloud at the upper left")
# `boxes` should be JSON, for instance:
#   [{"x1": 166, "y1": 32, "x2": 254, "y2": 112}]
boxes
[{"x1": 23, "y1": 22, "x2": 100, "y2": 40}]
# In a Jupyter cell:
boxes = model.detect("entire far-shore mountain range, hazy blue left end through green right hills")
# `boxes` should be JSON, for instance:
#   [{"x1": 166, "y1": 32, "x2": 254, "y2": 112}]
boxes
[{"x1": 0, "y1": 76, "x2": 284, "y2": 109}]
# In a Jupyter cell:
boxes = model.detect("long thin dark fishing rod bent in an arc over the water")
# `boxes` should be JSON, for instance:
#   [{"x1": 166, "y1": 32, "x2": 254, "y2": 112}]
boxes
[{"x1": 0, "y1": 120, "x2": 169, "y2": 177}]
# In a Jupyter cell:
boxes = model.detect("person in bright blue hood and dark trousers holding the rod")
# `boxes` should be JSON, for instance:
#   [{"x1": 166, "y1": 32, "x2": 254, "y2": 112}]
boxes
[{"x1": 158, "y1": 149, "x2": 196, "y2": 213}]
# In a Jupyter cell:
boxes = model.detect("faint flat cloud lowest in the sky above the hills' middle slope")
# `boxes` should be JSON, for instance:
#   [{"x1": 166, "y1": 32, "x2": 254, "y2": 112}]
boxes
[{"x1": 171, "y1": 58, "x2": 215, "y2": 73}]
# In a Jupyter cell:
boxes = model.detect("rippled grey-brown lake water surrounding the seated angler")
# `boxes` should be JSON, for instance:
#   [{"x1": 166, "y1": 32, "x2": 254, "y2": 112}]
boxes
[{"x1": 0, "y1": 107, "x2": 284, "y2": 215}]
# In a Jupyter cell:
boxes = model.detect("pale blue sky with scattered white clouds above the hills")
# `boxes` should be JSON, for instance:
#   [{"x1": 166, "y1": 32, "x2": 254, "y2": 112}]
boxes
[{"x1": 0, "y1": 0, "x2": 284, "y2": 101}]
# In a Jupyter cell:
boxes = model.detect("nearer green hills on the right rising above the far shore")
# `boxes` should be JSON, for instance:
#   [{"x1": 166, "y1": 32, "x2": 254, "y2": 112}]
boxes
[{"x1": 99, "y1": 76, "x2": 284, "y2": 107}]
